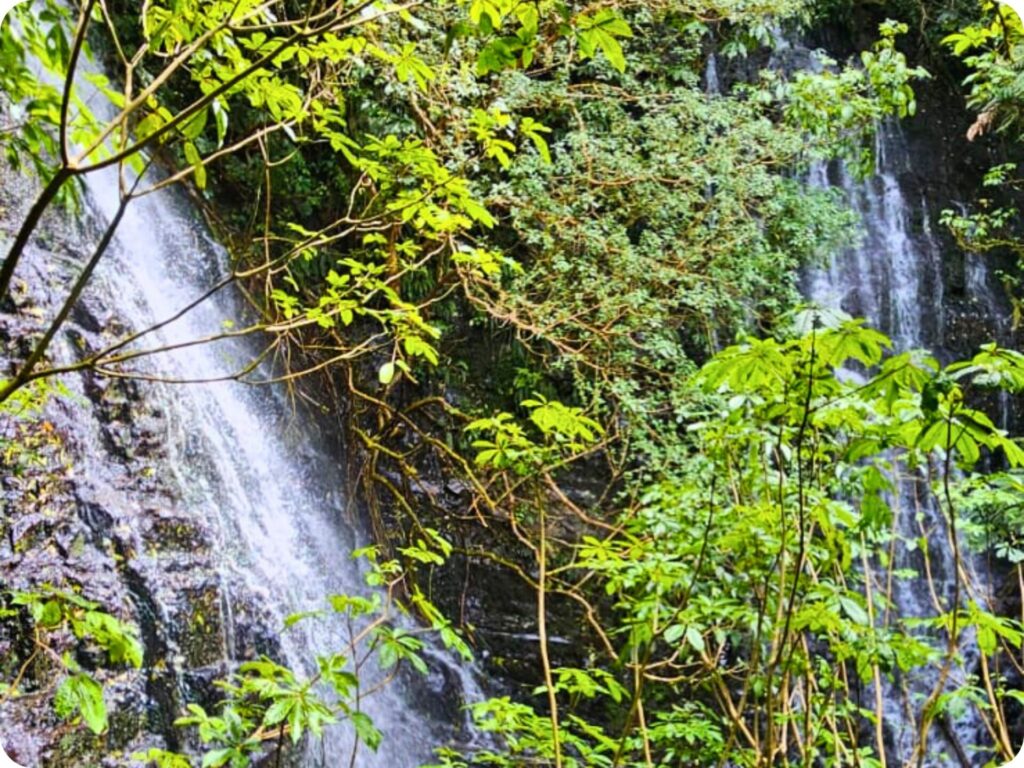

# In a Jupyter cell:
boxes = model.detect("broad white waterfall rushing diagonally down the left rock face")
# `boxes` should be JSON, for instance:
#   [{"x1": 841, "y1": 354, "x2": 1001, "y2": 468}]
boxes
[{"x1": 4, "y1": 55, "x2": 473, "y2": 768}]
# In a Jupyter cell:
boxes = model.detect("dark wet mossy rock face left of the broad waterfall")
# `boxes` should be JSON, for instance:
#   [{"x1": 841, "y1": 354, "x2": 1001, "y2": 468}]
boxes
[{"x1": 0, "y1": 210, "x2": 278, "y2": 768}]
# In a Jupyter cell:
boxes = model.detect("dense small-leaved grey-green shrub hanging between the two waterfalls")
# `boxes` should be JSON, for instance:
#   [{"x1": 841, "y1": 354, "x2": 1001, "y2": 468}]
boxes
[{"x1": 461, "y1": 13, "x2": 924, "y2": 438}]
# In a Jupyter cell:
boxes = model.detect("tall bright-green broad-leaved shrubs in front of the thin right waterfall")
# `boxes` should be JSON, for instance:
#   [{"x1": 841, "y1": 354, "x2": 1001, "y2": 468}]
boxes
[{"x1": 452, "y1": 309, "x2": 1024, "y2": 765}]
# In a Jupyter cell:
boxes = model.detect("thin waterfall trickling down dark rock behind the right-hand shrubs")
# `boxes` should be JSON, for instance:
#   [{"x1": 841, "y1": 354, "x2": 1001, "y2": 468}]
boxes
[{"x1": 804, "y1": 123, "x2": 997, "y2": 767}]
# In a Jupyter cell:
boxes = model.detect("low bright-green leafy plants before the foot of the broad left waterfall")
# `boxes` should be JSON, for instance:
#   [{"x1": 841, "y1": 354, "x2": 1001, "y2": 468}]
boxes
[{"x1": 125, "y1": 548, "x2": 472, "y2": 768}]
